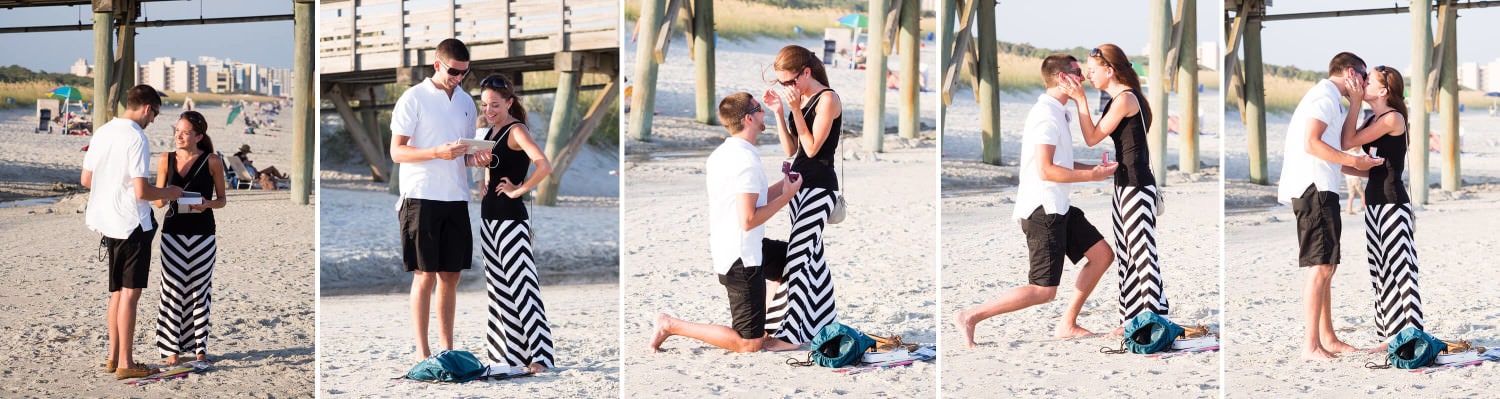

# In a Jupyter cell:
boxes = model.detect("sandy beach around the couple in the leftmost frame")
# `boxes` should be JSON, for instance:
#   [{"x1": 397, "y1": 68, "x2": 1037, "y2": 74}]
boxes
[{"x1": 0, "y1": 107, "x2": 317, "y2": 398}]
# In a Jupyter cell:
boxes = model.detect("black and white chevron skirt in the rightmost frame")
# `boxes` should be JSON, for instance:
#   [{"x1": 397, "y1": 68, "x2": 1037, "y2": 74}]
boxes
[{"x1": 1365, "y1": 204, "x2": 1422, "y2": 339}]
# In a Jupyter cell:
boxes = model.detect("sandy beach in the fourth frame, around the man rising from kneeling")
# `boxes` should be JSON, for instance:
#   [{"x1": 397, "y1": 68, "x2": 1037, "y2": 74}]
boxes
[{"x1": 941, "y1": 89, "x2": 1221, "y2": 398}]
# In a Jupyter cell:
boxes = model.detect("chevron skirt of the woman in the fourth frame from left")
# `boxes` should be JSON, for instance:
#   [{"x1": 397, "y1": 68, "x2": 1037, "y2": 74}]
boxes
[{"x1": 1112, "y1": 186, "x2": 1169, "y2": 326}]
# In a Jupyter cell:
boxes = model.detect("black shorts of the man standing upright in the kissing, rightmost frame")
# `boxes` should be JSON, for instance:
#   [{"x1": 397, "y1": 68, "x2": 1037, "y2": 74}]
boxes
[{"x1": 1292, "y1": 185, "x2": 1344, "y2": 267}]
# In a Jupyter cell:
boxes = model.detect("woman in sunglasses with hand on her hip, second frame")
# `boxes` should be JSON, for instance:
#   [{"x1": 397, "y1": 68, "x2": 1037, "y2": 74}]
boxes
[{"x1": 473, "y1": 75, "x2": 554, "y2": 372}]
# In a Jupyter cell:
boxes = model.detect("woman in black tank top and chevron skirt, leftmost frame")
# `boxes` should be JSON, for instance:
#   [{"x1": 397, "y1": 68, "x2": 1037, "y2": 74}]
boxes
[{"x1": 155, "y1": 111, "x2": 227, "y2": 365}]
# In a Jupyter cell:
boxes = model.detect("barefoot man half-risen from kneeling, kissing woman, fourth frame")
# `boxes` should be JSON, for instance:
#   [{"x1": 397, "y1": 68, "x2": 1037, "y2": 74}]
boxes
[{"x1": 954, "y1": 54, "x2": 1116, "y2": 348}]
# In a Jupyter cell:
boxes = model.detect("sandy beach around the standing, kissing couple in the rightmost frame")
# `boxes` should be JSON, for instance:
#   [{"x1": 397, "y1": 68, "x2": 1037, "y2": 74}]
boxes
[{"x1": 1224, "y1": 105, "x2": 1500, "y2": 398}]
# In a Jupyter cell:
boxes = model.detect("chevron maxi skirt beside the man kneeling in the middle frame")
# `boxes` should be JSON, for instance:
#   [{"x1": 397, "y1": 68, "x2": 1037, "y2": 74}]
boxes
[{"x1": 765, "y1": 188, "x2": 839, "y2": 344}]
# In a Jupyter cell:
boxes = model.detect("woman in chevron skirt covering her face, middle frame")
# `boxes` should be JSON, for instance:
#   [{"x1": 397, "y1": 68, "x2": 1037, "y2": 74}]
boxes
[{"x1": 762, "y1": 45, "x2": 843, "y2": 344}]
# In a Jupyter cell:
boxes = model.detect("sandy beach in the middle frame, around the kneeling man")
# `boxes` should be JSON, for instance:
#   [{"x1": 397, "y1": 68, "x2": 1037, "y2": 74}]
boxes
[{"x1": 621, "y1": 30, "x2": 938, "y2": 398}]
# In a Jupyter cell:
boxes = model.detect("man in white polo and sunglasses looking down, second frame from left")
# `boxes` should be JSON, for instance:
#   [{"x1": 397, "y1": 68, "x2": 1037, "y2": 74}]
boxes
[{"x1": 390, "y1": 39, "x2": 489, "y2": 359}]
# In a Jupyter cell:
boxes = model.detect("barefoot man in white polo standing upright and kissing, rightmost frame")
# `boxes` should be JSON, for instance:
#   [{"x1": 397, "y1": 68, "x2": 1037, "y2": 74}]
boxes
[{"x1": 1277, "y1": 53, "x2": 1385, "y2": 360}]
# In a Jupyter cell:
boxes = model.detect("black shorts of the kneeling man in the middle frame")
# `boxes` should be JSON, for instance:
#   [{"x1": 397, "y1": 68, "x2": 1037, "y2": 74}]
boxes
[{"x1": 719, "y1": 239, "x2": 786, "y2": 339}]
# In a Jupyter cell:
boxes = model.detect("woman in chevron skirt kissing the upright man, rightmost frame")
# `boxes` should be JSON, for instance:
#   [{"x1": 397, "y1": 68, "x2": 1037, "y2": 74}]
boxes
[{"x1": 1341, "y1": 66, "x2": 1424, "y2": 341}]
